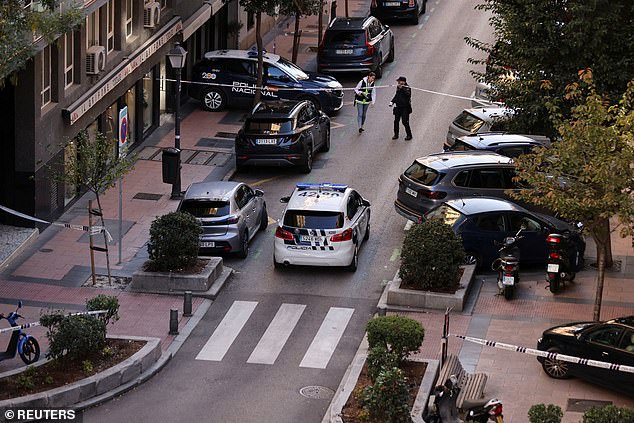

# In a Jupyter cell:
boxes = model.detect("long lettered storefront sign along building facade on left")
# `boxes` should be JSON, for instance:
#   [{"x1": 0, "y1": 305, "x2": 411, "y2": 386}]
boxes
[{"x1": 67, "y1": 18, "x2": 183, "y2": 125}]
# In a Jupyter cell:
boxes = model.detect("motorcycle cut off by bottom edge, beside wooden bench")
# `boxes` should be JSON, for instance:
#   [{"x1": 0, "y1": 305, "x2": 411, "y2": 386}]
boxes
[{"x1": 422, "y1": 375, "x2": 504, "y2": 423}]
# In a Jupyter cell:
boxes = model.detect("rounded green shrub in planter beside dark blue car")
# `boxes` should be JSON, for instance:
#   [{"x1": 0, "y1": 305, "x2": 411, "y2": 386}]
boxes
[{"x1": 399, "y1": 219, "x2": 465, "y2": 290}]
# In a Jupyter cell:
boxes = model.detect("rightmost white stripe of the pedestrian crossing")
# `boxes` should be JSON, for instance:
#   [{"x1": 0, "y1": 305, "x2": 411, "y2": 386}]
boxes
[{"x1": 299, "y1": 307, "x2": 354, "y2": 369}]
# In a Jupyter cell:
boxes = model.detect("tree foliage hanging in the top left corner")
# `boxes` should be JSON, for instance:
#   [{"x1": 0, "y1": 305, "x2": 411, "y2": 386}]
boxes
[{"x1": 0, "y1": 0, "x2": 83, "y2": 84}]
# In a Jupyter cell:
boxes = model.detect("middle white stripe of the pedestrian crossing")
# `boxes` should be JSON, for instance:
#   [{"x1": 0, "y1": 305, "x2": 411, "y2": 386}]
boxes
[{"x1": 247, "y1": 304, "x2": 306, "y2": 364}]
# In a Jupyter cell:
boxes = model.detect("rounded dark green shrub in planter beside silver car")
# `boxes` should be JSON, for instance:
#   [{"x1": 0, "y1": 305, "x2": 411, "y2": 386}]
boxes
[{"x1": 147, "y1": 212, "x2": 202, "y2": 272}]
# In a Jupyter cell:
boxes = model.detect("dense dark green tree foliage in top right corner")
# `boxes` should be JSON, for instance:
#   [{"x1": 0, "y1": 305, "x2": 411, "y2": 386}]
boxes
[{"x1": 465, "y1": 0, "x2": 634, "y2": 137}]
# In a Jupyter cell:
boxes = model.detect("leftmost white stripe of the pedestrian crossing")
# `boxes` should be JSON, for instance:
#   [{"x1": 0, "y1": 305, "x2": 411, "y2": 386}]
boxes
[{"x1": 196, "y1": 301, "x2": 258, "y2": 361}]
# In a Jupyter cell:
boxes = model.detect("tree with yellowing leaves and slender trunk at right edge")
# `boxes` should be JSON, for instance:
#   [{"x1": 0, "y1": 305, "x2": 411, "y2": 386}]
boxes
[{"x1": 512, "y1": 75, "x2": 634, "y2": 320}]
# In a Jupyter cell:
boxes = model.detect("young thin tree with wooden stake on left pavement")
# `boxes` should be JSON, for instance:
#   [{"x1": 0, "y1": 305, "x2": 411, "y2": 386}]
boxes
[{"x1": 53, "y1": 130, "x2": 135, "y2": 283}]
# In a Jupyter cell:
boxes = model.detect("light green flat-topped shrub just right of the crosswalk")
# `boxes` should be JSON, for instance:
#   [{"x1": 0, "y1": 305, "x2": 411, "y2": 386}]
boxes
[{"x1": 366, "y1": 316, "x2": 425, "y2": 362}]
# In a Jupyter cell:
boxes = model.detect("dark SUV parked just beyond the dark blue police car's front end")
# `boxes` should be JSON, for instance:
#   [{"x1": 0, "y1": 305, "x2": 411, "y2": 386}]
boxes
[{"x1": 317, "y1": 16, "x2": 394, "y2": 78}]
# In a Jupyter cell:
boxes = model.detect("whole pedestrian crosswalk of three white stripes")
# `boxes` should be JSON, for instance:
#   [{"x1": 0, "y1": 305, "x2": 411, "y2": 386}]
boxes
[{"x1": 196, "y1": 301, "x2": 354, "y2": 369}]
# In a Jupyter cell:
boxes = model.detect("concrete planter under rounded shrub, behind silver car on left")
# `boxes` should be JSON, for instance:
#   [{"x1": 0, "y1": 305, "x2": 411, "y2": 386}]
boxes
[{"x1": 130, "y1": 257, "x2": 223, "y2": 293}]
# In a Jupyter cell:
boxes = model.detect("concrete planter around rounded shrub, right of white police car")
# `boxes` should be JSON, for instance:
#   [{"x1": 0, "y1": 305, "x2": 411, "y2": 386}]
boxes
[{"x1": 386, "y1": 264, "x2": 475, "y2": 311}]
